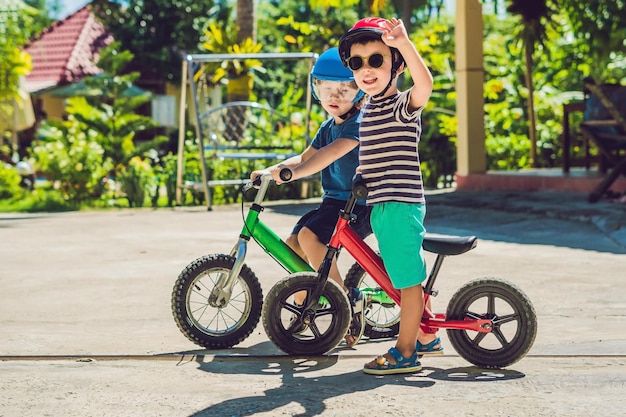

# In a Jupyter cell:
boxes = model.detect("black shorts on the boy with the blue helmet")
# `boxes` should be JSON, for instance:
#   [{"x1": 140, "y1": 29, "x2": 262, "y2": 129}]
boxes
[{"x1": 291, "y1": 198, "x2": 372, "y2": 245}]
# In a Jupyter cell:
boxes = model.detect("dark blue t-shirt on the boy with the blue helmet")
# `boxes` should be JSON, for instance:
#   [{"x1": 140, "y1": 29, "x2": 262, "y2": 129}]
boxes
[{"x1": 311, "y1": 112, "x2": 365, "y2": 204}]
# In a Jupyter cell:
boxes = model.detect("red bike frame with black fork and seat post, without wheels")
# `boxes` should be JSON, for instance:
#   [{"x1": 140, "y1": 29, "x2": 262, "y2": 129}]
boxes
[{"x1": 311, "y1": 196, "x2": 492, "y2": 333}]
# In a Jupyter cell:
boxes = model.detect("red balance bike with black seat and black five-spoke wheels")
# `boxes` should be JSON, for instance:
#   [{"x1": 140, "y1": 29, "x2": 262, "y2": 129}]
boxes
[{"x1": 262, "y1": 170, "x2": 537, "y2": 368}]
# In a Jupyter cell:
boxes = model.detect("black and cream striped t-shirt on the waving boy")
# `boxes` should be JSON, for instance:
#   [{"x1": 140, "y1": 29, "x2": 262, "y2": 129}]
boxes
[{"x1": 359, "y1": 89, "x2": 426, "y2": 205}]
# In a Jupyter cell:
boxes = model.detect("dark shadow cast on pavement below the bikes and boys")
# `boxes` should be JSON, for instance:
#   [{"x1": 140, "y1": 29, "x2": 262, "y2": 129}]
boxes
[{"x1": 192, "y1": 356, "x2": 525, "y2": 417}]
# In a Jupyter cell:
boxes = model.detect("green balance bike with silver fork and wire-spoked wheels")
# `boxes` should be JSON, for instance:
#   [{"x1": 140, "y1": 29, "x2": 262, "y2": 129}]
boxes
[{"x1": 171, "y1": 174, "x2": 400, "y2": 349}]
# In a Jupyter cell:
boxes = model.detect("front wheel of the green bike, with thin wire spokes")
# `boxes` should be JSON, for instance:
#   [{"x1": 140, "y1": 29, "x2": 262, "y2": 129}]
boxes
[{"x1": 172, "y1": 254, "x2": 263, "y2": 349}]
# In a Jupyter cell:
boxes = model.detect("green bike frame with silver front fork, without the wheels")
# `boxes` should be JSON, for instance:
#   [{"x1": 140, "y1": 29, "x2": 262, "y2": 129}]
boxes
[{"x1": 209, "y1": 174, "x2": 314, "y2": 307}]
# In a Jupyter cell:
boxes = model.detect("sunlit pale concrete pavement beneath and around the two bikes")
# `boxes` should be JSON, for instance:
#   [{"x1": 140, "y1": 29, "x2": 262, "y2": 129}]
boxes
[{"x1": 0, "y1": 191, "x2": 626, "y2": 417}]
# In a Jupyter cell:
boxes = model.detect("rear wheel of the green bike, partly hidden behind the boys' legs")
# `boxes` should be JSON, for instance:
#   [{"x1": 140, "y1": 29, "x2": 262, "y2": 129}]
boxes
[{"x1": 344, "y1": 263, "x2": 400, "y2": 339}]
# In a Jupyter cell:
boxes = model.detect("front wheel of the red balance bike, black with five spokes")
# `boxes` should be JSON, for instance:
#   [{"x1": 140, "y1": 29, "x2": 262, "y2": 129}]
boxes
[{"x1": 263, "y1": 272, "x2": 352, "y2": 356}]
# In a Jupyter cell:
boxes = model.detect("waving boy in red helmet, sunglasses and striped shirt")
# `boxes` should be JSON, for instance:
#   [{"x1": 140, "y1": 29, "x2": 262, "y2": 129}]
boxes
[{"x1": 339, "y1": 17, "x2": 443, "y2": 375}]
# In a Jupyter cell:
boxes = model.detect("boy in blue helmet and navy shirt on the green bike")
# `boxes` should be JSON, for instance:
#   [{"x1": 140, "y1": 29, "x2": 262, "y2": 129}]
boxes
[{"x1": 250, "y1": 48, "x2": 372, "y2": 346}]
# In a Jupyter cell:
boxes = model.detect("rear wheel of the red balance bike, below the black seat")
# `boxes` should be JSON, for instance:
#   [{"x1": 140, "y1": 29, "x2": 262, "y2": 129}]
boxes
[{"x1": 446, "y1": 278, "x2": 537, "y2": 368}]
